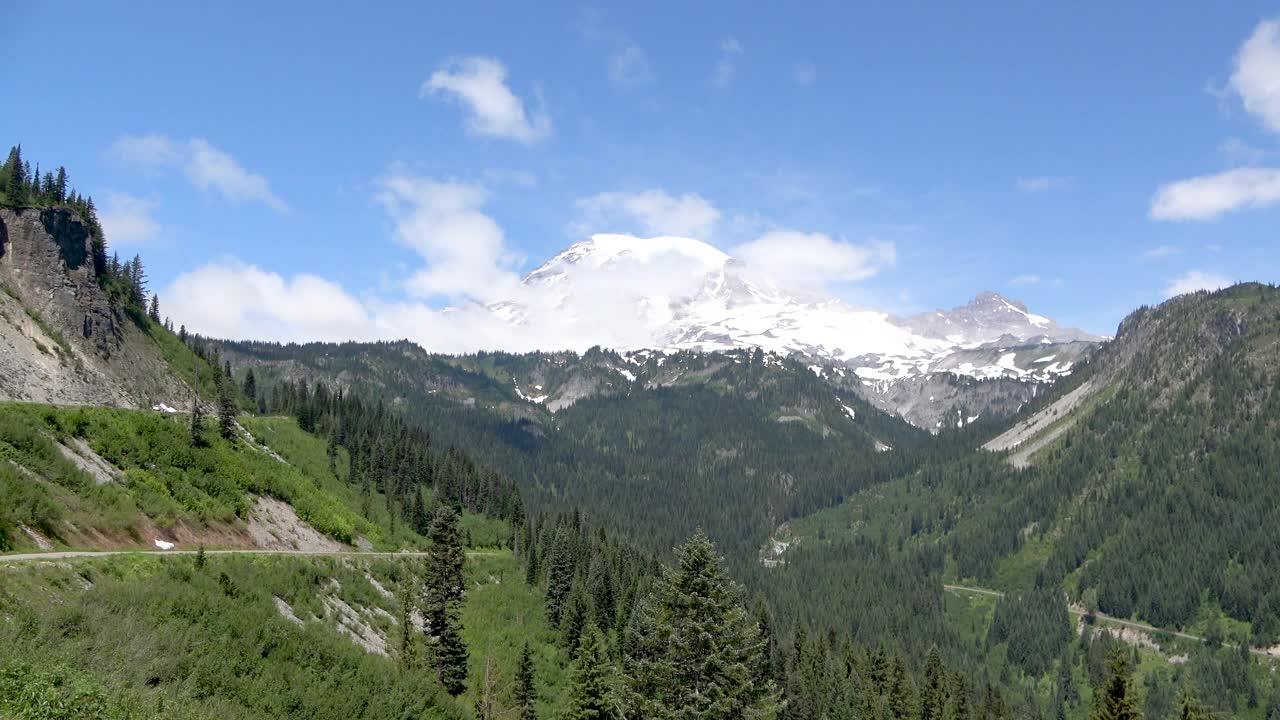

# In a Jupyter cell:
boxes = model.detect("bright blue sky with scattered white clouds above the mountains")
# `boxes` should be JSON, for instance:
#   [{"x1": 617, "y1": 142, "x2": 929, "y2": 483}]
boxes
[{"x1": 0, "y1": 1, "x2": 1280, "y2": 346}]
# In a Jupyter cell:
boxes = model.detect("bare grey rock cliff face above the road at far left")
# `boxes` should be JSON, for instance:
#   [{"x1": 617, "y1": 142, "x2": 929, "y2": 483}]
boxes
[{"x1": 0, "y1": 209, "x2": 191, "y2": 407}]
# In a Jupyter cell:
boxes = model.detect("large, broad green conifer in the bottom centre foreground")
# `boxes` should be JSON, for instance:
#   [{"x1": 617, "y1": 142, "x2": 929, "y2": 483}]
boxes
[{"x1": 624, "y1": 530, "x2": 780, "y2": 720}]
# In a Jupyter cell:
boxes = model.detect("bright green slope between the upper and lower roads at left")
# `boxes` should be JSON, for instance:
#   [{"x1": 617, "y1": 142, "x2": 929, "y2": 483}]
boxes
[{"x1": 0, "y1": 404, "x2": 387, "y2": 543}]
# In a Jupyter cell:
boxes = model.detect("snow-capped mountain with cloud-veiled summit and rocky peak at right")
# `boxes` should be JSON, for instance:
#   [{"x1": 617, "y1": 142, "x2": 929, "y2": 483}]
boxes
[{"x1": 489, "y1": 234, "x2": 1102, "y2": 427}]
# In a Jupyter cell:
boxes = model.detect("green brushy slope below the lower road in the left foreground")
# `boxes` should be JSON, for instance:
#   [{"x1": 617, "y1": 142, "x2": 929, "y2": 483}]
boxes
[{"x1": 0, "y1": 552, "x2": 566, "y2": 720}]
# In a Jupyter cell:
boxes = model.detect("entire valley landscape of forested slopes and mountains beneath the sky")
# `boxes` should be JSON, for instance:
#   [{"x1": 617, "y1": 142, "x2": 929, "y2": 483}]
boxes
[{"x1": 0, "y1": 147, "x2": 1280, "y2": 720}]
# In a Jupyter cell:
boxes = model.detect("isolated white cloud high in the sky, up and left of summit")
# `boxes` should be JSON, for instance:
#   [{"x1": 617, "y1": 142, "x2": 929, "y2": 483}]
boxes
[{"x1": 420, "y1": 56, "x2": 552, "y2": 145}]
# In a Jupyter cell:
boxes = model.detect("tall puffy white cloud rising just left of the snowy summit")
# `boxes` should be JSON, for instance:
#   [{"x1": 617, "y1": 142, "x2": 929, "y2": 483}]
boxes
[{"x1": 379, "y1": 176, "x2": 520, "y2": 300}]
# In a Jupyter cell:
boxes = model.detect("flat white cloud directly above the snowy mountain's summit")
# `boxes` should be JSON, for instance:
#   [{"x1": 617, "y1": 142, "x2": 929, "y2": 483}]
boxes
[{"x1": 570, "y1": 188, "x2": 721, "y2": 240}]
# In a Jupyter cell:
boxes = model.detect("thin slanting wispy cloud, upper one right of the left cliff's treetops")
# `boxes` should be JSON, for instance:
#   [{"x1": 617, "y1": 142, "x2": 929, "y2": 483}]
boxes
[{"x1": 109, "y1": 135, "x2": 289, "y2": 213}]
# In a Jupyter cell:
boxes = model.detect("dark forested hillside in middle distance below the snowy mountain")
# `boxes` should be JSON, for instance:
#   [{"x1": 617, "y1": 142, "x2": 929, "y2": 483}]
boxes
[{"x1": 211, "y1": 342, "x2": 963, "y2": 569}]
